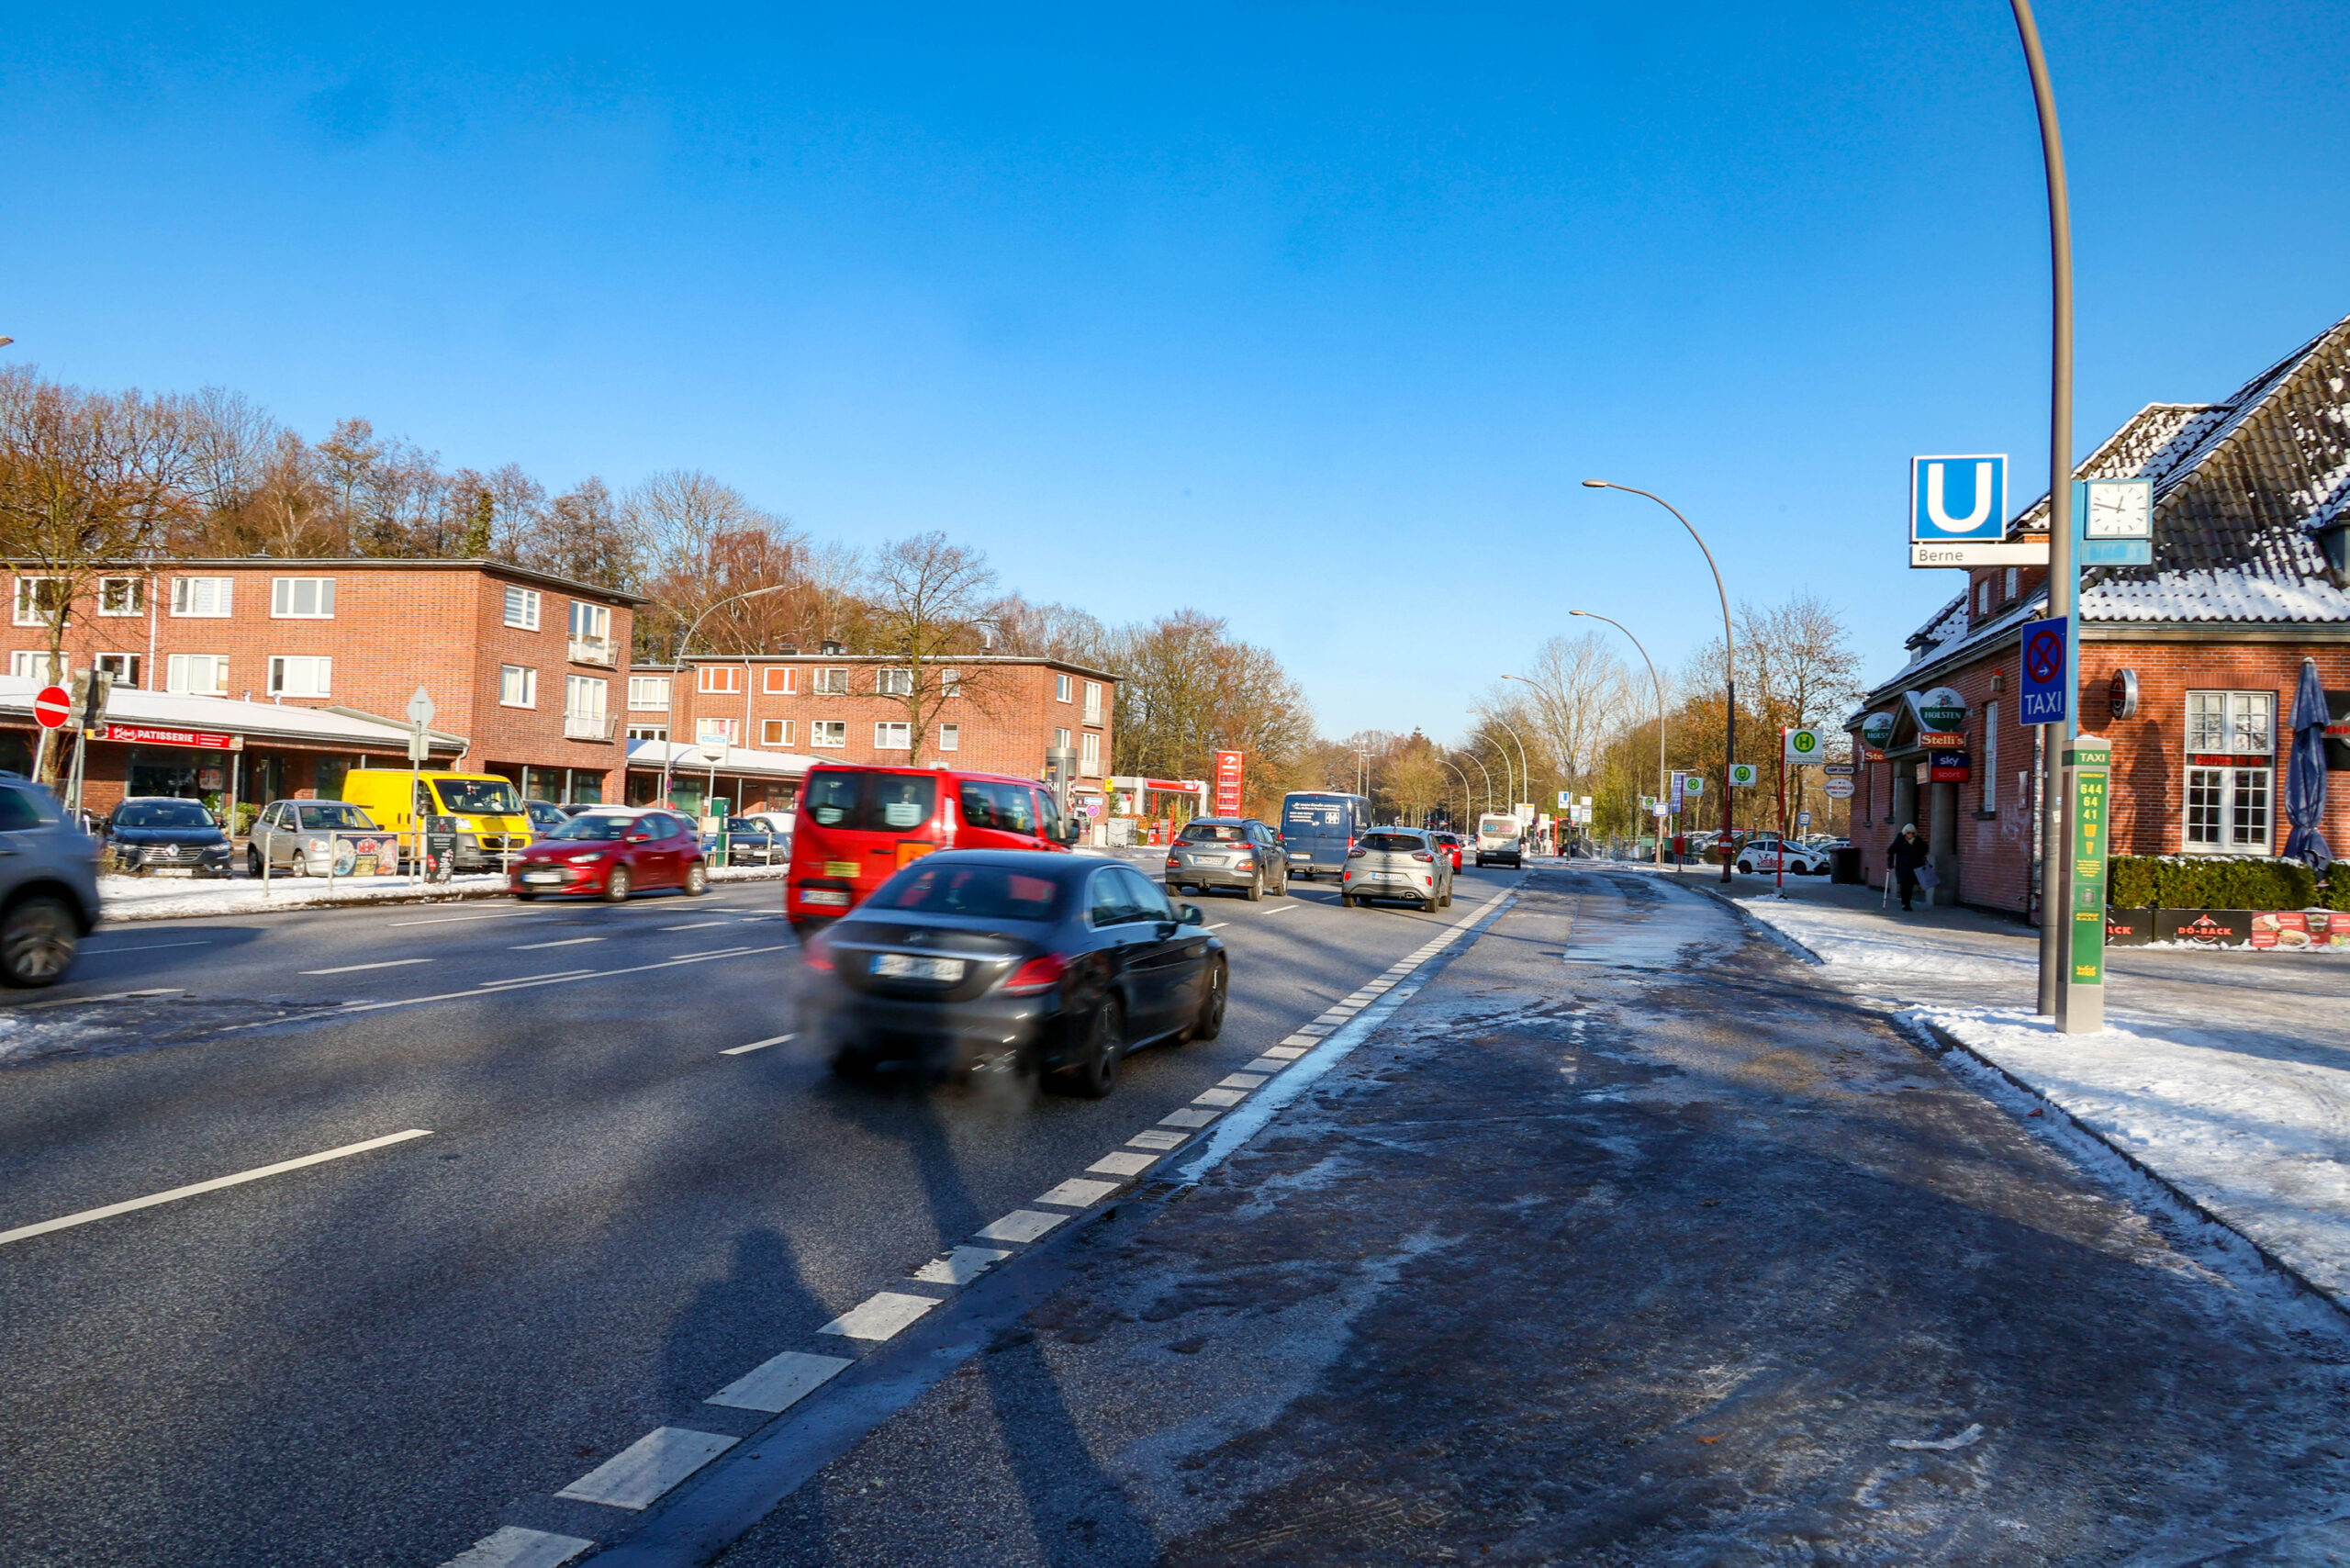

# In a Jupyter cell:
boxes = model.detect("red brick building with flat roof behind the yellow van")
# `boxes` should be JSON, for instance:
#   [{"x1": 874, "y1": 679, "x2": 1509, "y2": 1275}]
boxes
[{"x1": 0, "y1": 557, "x2": 643, "y2": 809}]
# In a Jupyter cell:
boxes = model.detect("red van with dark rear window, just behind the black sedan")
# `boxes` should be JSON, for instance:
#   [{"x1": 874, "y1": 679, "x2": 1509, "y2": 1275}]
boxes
[{"x1": 782, "y1": 767, "x2": 1076, "y2": 934}]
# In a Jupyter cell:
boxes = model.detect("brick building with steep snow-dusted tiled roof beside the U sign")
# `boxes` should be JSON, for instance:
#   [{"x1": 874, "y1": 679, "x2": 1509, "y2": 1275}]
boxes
[{"x1": 1847, "y1": 319, "x2": 2350, "y2": 913}]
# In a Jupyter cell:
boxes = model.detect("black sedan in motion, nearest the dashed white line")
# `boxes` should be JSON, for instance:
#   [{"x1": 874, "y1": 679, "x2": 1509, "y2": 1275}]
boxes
[{"x1": 799, "y1": 848, "x2": 1226, "y2": 1098}]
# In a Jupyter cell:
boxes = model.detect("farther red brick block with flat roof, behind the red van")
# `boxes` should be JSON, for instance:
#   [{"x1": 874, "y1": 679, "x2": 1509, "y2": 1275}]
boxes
[{"x1": 625, "y1": 651, "x2": 1119, "y2": 811}]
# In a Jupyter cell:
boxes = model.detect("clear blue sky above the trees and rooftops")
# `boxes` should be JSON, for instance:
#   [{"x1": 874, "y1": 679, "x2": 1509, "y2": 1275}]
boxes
[{"x1": 0, "y1": 0, "x2": 2350, "y2": 736}]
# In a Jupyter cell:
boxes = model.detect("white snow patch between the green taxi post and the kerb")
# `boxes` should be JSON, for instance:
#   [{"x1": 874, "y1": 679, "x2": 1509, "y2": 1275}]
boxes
[{"x1": 1910, "y1": 1006, "x2": 2350, "y2": 1305}]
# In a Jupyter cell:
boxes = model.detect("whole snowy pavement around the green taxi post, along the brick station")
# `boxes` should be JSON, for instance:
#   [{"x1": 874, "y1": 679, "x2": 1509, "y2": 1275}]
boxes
[{"x1": 1739, "y1": 898, "x2": 2350, "y2": 1309}]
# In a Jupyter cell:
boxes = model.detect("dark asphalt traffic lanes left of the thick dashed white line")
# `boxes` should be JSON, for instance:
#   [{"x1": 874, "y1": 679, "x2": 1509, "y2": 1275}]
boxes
[{"x1": 0, "y1": 872, "x2": 1511, "y2": 1568}]
